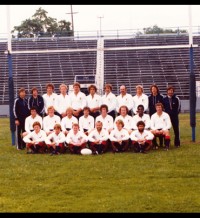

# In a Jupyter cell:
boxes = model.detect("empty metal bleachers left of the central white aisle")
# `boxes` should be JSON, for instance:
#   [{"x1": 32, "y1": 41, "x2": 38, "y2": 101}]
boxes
[{"x1": 0, "y1": 38, "x2": 97, "y2": 105}]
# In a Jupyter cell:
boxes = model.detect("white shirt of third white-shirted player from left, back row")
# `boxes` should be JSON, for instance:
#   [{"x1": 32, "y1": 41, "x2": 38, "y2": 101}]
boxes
[{"x1": 69, "y1": 91, "x2": 87, "y2": 110}]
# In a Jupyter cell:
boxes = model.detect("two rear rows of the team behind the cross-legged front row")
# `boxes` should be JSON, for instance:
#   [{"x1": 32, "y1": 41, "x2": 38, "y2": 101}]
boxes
[{"x1": 13, "y1": 83, "x2": 181, "y2": 153}]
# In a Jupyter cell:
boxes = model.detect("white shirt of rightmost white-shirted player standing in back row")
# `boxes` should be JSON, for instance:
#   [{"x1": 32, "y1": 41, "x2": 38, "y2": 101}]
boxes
[{"x1": 133, "y1": 93, "x2": 149, "y2": 114}]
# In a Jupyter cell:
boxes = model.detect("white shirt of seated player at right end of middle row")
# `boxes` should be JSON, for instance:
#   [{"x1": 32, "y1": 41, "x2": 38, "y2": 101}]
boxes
[{"x1": 151, "y1": 111, "x2": 172, "y2": 130}]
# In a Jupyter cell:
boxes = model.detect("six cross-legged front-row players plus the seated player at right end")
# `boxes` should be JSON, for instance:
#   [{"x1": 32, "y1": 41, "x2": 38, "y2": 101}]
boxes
[{"x1": 23, "y1": 103, "x2": 171, "y2": 155}]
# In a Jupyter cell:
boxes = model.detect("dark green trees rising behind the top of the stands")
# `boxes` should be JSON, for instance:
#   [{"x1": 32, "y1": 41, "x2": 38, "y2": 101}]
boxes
[{"x1": 11, "y1": 7, "x2": 187, "y2": 38}]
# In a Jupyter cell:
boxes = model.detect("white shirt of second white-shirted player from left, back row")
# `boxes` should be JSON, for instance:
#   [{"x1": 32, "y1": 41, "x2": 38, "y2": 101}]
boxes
[{"x1": 55, "y1": 94, "x2": 71, "y2": 114}]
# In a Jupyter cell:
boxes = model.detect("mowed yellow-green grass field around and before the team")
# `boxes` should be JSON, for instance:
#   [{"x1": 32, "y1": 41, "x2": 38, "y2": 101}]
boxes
[{"x1": 0, "y1": 113, "x2": 200, "y2": 213}]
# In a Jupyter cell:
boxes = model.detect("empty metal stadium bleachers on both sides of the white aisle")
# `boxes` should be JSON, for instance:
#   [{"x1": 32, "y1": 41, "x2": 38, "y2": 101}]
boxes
[{"x1": 0, "y1": 35, "x2": 200, "y2": 105}]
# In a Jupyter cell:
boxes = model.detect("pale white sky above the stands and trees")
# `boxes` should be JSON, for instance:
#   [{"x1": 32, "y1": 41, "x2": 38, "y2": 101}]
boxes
[{"x1": 0, "y1": 4, "x2": 200, "y2": 35}]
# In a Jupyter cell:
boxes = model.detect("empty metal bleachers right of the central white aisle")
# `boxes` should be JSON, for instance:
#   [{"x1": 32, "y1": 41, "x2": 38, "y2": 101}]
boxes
[{"x1": 104, "y1": 35, "x2": 200, "y2": 96}]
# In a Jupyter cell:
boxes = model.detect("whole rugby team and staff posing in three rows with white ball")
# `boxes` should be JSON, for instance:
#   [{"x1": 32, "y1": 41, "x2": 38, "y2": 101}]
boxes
[{"x1": 13, "y1": 82, "x2": 181, "y2": 155}]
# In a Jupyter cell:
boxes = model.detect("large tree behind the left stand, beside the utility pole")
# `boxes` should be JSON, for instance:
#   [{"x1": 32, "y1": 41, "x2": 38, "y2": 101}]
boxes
[{"x1": 11, "y1": 7, "x2": 73, "y2": 38}]
